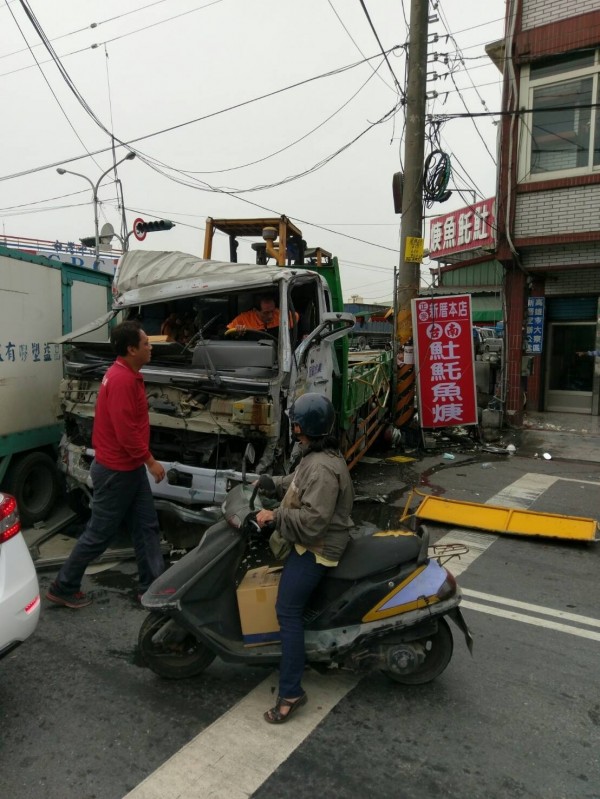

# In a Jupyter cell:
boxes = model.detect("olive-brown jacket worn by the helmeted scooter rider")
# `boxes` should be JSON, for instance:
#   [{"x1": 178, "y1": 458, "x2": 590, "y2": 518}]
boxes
[{"x1": 274, "y1": 451, "x2": 354, "y2": 562}]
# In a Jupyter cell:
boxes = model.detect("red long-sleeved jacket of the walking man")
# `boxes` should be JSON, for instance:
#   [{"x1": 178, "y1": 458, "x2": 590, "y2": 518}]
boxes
[{"x1": 92, "y1": 358, "x2": 152, "y2": 472}]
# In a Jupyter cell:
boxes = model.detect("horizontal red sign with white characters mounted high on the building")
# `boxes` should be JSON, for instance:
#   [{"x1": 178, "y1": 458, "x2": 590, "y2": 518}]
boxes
[{"x1": 429, "y1": 198, "x2": 496, "y2": 260}]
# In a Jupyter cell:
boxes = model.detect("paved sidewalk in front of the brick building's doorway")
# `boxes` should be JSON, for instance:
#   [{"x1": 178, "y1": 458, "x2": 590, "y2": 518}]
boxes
[{"x1": 515, "y1": 413, "x2": 600, "y2": 464}]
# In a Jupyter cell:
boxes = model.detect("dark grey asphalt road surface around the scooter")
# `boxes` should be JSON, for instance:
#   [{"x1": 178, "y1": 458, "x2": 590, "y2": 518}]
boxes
[{"x1": 0, "y1": 455, "x2": 600, "y2": 799}]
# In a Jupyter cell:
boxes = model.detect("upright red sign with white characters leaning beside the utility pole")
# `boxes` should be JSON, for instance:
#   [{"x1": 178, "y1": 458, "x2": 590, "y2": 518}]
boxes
[{"x1": 412, "y1": 294, "x2": 477, "y2": 427}]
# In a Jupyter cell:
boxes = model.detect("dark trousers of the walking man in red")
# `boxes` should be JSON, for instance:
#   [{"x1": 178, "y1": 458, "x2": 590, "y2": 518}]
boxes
[{"x1": 55, "y1": 461, "x2": 165, "y2": 594}]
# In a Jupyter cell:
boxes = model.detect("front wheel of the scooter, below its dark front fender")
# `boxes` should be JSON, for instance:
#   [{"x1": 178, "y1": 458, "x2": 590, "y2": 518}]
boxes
[{"x1": 138, "y1": 613, "x2": 215, "y2": 680}]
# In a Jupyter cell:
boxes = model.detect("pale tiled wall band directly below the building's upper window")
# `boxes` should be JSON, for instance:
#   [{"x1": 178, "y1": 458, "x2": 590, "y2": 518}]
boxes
[{"x1": 515, "y1": 184, "x2": 600, "y2": 238}]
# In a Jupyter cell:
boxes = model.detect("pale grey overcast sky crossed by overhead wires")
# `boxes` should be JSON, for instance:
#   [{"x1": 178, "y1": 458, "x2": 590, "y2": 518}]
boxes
[{"x1": 0, "y1": 0, "x2": 505, "y2": 302}]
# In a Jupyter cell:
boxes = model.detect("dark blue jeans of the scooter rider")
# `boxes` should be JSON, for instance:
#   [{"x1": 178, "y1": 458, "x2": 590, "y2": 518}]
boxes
[{"x1": 275, "y1": 547, "x2": 328, "y2": 699}]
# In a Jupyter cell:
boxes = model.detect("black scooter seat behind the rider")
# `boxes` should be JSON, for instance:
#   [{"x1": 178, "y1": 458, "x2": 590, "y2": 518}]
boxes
[{"x1": 329, "y1": 534, "x2": 423, "y2": 580}]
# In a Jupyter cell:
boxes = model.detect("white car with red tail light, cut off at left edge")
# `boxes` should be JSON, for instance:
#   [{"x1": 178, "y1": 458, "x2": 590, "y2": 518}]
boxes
[{"x1": 0, "y1": 492, "x2": 40, "y2": 658}]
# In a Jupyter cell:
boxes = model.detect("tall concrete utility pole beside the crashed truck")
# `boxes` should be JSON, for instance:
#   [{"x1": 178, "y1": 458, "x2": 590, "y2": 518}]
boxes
[{"x1": 395, "y1": 0, "x2": 429, "y2": 427}]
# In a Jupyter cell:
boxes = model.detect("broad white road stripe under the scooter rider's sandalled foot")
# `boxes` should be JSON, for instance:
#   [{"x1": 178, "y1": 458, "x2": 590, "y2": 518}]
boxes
[{"x1": 125, "y1": 671, "x2": 359, "y2": 799}]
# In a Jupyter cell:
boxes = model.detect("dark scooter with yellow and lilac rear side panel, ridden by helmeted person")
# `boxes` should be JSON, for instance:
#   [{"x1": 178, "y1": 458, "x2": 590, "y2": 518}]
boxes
[{"x1": 138, "y1": 475, "x2": 472, "y2": 685}]
